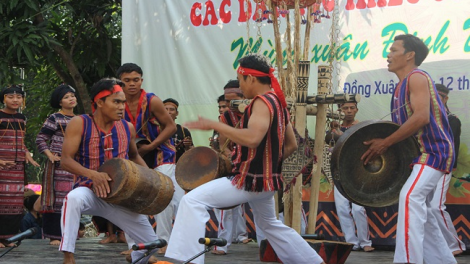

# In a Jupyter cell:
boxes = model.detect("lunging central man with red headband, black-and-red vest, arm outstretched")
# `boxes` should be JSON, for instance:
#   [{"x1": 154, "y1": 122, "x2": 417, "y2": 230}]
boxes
[{"x1": 166, "y1": 54, "x2": 324, "y2": 264}]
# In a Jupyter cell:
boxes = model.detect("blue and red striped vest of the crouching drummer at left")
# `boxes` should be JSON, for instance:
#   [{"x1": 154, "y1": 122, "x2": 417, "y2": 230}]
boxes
[{"x1": 74, "y1": 115, "x2": 131, "y2": 188}]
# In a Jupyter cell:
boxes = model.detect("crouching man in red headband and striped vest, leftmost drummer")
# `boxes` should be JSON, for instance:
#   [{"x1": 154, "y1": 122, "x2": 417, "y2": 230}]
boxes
[{"x1": 59, "y1": 79, "x2": 157, "y2": 264}]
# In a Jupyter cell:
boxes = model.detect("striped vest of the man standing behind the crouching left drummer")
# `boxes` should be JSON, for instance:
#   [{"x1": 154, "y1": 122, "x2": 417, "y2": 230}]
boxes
[{"x1": 124, "y1": 89, "x2": 176, "y2": 168}]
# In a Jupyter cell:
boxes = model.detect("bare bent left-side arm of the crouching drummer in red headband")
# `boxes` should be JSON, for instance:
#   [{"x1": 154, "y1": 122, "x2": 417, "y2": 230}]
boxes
[{"x1": 60, "y1": 116, "x2": 111, "y2": 197}]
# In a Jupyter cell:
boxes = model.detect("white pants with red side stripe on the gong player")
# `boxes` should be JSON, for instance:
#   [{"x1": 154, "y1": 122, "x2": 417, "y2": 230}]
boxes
[{"x1": 393, "y1": 164, "x2": 457, "y2": 264}]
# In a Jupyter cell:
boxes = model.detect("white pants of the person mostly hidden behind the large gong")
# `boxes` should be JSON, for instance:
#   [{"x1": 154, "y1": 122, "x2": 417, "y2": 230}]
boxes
[{"x1": 334, "y1": 186, "x2": 372, "y2": 250}]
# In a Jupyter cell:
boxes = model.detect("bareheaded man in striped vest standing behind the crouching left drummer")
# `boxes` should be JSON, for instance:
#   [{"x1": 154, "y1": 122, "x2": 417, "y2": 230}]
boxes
[{"x1": 117, "y1": 63, "x2": 184, "y2": 254}]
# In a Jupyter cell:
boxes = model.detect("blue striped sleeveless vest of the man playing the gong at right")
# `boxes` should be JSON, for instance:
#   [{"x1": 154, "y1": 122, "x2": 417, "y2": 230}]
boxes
[{"x1": 391, "y1": 69, "x2": 454, "y2": 173}]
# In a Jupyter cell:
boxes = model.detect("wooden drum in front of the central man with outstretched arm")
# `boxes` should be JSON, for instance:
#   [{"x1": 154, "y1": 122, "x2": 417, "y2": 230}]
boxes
[{"x1": 175, "y1": 147, "x2": 232, "y2": 191}]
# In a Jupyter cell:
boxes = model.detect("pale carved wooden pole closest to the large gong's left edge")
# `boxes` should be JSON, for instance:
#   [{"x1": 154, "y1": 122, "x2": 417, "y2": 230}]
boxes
[{"x1": 307, "y1": 66, "x2": 332, "y2": 234}]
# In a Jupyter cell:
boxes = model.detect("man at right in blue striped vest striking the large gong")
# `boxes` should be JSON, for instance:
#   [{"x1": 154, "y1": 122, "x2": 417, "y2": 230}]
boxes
[{"x1": 361, "y1": 34, "x2": 457, "y2": 264}]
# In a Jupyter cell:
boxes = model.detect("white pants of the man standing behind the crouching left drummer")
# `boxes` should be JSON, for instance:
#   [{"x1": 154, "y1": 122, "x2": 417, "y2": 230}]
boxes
[{"x1": 155, "y1": 164, "x2": 184, "y2": 241}]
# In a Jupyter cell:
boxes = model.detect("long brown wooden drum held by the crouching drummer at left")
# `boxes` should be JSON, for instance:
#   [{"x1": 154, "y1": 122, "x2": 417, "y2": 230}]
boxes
[{"x1": 98, "y1": 158, "x2": 175, "y2": 215}]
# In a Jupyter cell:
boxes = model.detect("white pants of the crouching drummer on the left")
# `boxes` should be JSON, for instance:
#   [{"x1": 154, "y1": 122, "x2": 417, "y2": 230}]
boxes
[{"x1": 59, "y1": 187, "x2": 157, "y2": 263}]
